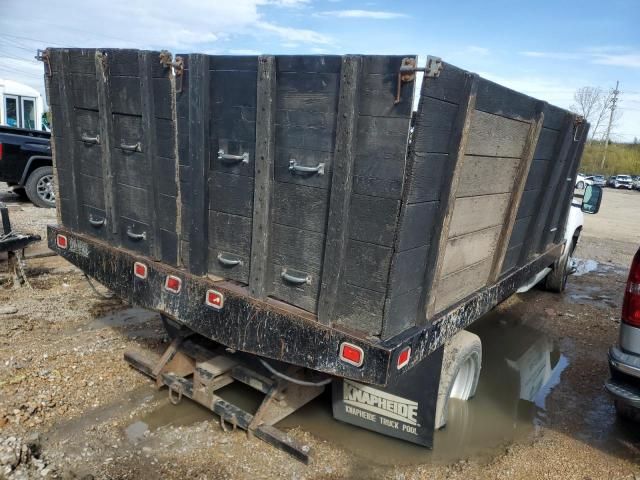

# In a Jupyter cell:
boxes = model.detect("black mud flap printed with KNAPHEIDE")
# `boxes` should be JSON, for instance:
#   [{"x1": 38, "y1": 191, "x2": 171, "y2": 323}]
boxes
[{"x1": 332, "y1": 347, "x2": 444, "y2": 448}]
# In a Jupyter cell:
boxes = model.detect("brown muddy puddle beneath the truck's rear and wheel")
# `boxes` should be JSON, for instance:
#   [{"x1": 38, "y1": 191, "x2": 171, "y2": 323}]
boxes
[{"x1": 125, "y1": 312, "x2": 569, "y2": 465}]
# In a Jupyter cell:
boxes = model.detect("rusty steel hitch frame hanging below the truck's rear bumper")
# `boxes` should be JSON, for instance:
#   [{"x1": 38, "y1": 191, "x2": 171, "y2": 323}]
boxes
[{"x1": 124, "y1": 333, "x2": 324, "y2": 463}]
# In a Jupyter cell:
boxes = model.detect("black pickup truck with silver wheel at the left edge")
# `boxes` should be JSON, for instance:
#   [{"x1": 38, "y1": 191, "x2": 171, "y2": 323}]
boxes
[{"x1": 0, "y1": 127, "x2": 56, "y2": 208}]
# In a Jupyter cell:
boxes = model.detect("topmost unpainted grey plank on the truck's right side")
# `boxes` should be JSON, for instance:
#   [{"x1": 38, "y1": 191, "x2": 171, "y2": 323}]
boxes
[{"x1": 466, "y1": 111, "x2": 529, "y2": 158}]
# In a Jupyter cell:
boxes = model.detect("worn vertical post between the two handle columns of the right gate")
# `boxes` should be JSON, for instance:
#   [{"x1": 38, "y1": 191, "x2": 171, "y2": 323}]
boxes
[{"x1": 249, "y1": 56, "x2": 277, "y2": 298}]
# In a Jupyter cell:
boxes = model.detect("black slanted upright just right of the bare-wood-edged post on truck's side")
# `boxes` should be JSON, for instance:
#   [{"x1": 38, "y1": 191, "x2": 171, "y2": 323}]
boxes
[{"x1": 518, "y1": 114, "x2": 575, "y2": 264}]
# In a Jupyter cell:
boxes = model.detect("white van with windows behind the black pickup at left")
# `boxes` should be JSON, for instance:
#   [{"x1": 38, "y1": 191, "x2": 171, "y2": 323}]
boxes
[{"x1": 0, "y1": 79, "x2": 44, "y2": 130}]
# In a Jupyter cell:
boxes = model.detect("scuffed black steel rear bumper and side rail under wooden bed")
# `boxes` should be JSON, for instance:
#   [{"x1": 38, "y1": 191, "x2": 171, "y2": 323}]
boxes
[{"x1": 47, "y1": 225, "x2": 562, "y2": 386}]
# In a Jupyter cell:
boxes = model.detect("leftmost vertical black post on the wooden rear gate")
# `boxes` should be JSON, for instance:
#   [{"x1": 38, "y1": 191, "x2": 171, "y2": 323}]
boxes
[{"x1": 53, "y1": 49, "x2": 80, "y2": 230}]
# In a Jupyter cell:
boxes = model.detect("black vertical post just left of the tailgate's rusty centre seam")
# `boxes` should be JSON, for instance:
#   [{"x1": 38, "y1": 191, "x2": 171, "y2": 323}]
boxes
[{"x1": 138, "y1": 51, "x2": 162, "y2": 260}]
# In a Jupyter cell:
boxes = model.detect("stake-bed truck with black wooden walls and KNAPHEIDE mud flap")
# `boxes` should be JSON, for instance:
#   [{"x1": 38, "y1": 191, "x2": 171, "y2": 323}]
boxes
[{"x1": 42, "y1": 48, "x2": 601, "y2": 461}]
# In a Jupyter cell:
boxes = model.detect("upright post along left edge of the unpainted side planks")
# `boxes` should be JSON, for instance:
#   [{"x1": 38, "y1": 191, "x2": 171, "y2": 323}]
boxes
[{"x1": 418, "y1": 73, "x2": 480, "y2": 324}]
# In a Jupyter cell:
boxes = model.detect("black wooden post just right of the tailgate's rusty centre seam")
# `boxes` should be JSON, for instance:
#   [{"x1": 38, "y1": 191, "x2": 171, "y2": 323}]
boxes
[{"x1": 186, "y1": 54, "x2": 211, "y2": 275}]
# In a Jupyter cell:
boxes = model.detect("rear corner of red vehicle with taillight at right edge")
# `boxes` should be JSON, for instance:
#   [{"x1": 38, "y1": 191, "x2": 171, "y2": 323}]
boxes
[{"x1": 605, "y1": 249, "x2": 640, "y2": 421}]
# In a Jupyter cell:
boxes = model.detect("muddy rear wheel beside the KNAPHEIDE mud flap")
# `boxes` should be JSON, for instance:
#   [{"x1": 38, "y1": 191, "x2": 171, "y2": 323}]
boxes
[{"x1": 434, "y1": 330, "x2": 482, "y2": 430}]
